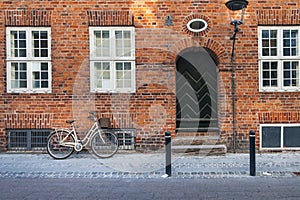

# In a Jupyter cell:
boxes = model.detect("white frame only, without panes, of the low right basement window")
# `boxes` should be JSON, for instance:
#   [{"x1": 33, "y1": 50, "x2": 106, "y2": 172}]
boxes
[{"x1": 259, "y1": 124, "x2": 300, "y2": 150}]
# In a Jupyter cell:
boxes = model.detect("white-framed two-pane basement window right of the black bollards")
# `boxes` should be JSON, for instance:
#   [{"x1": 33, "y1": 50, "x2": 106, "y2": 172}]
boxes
[{"x1": 260, "y1": 124, "x2": 300, "y2": 150}]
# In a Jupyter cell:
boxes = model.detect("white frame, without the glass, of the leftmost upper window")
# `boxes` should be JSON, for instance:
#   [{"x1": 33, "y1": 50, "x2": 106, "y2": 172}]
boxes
[{"x1": 6, "y1": 27, "x2": 52, "y2": 93}]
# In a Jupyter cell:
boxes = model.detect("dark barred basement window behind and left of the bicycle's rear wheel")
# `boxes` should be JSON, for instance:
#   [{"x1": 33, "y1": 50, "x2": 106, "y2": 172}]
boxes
[{"x1": 7, "y1": 129, "x2": 51, "y2": 151}]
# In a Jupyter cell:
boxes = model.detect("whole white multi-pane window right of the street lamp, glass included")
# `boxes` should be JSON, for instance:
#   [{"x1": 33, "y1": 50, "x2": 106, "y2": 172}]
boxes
[{"x1": 258, "y1": 26, "x2": 300, "y2": 92}]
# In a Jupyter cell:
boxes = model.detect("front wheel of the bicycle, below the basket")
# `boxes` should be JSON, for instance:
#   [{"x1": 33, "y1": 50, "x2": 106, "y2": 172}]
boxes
[{"x1": 91, "y1": 130, "x2": 119, "y2": 158}]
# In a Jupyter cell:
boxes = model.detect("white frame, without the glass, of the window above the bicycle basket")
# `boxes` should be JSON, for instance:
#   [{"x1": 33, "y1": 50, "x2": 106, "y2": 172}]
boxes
[{"x1": 89, "y1": 27, "x2": 136, "y2": 93}]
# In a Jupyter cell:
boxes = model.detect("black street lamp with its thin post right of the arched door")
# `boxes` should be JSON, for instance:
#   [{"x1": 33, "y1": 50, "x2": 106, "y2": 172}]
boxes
[{"x1": 225, "y1": 0, "x2": 248, "y2": 152}]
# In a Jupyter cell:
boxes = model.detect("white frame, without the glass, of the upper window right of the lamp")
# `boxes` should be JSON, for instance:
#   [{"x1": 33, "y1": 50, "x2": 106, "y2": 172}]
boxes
[{"x1": 258, "y1": 26, "x2": 300, "y2": 92}]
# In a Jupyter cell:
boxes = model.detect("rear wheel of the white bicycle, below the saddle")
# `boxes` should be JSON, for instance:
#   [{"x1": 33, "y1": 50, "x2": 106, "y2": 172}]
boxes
[{"x1": 47, "y1": 130, "x2": 75, "y2": 159}]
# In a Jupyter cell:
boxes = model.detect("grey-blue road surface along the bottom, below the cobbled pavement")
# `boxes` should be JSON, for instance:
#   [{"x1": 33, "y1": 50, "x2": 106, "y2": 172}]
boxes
[{"x1": 0, "y1": 176, "x2": 300, "y2": 200}]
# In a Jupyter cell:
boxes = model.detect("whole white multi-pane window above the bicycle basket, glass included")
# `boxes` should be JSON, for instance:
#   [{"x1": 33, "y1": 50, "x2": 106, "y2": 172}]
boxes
[{"x1": 90, "y1": 27, "x2": 135, "y2": 93}]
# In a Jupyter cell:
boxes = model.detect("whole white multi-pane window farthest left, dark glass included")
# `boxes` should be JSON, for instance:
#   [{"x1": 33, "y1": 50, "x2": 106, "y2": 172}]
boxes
[{"x1": 6, "y1": 27, "x2": 52, "y2": 93}]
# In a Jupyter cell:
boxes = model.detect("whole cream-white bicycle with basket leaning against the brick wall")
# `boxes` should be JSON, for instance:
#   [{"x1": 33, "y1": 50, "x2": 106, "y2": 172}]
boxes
[{"x1": 47, "y1": 112, "x2": 118, "y2": 159}]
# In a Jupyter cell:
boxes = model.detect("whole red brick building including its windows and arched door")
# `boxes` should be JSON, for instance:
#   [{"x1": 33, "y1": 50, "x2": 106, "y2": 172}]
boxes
[{"x1": 0, "y1": 0, "x2": 300, "y2": 152}]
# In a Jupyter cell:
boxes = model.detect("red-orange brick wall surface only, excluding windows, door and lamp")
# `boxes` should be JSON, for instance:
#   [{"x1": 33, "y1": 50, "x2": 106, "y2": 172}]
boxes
[{"x1": 0, "y1": 0, "x2": 300, "y2": 151}]
